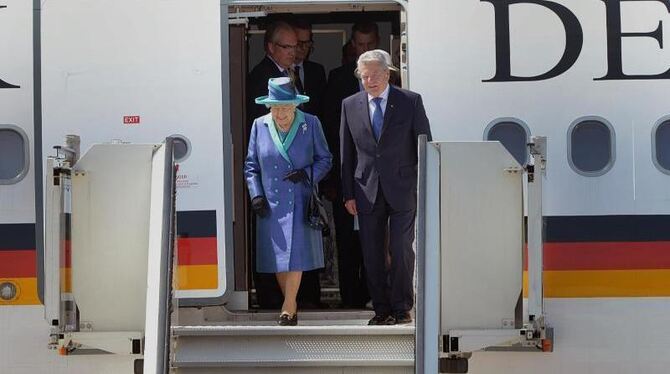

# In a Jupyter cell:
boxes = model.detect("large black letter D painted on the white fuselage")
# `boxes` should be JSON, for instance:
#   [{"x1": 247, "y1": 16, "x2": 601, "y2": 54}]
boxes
[{"x1": 480, "y1": 0, "x2": 584, "y2": 82}]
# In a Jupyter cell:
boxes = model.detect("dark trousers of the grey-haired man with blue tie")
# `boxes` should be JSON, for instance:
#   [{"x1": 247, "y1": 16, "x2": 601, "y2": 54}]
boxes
[{"x1": 358, "y1": 185, "x2": 416, "y2": 314}]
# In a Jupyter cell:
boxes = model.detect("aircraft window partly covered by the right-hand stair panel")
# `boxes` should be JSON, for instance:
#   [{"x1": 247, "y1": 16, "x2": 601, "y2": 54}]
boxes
[{"x1": 484, "y1": 118, "x2": 530, "y2": 166}]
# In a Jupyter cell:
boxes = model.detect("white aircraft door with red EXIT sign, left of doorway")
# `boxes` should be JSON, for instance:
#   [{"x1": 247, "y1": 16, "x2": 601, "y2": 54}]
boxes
[{"x1": 42, "y1": 0, "x2": 229, "y2": 304}]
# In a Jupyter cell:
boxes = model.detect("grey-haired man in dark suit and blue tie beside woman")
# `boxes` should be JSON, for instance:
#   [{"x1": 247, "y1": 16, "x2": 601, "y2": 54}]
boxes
[{"x1": 340, "y1": 49, "x2": 431, "y2": 325}]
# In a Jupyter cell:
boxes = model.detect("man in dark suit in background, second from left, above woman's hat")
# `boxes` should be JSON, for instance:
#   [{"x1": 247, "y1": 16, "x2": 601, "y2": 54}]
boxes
[{"x1": 293, "y1": 20, "x2": 332, "y2": 118}]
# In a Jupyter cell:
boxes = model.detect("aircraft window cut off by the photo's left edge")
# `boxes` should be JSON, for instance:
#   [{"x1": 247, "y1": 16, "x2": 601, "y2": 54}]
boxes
[{"x1": 0, "y1": 125, "x2": 30, "y2": 184}]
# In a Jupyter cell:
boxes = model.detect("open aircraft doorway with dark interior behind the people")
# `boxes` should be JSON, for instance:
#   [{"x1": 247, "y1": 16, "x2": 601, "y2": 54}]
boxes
[{"x1": 228, "y1": 1, "x2": 407, "y2": 310}]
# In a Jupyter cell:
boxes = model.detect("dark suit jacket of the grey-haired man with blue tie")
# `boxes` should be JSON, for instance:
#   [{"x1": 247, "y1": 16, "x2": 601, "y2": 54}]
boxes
[{"x1": 340, "y1": 86, "x2": 431, "y2": 213}]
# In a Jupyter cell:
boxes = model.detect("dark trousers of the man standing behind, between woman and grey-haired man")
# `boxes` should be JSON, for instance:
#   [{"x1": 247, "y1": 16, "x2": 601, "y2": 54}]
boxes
[{"x1": 333, "y1": 191, "x2": 370, "y2": 308}]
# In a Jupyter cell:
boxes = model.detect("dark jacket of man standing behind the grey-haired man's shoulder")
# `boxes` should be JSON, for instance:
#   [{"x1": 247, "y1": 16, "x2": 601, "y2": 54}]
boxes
[{"x1": 321, "y1": 62, "x2": 360, "y2": 189}]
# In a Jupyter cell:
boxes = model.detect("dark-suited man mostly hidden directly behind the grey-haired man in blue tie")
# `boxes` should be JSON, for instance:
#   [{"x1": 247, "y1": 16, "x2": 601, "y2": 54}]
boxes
[{"x1": 322, "y1": 22, "x2": 379, "y2": 308}]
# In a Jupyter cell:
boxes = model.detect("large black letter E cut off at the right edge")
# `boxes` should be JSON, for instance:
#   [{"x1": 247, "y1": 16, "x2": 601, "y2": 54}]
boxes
[{"x1": 594, "y1": 0, "x2": 670, "y2": 81}]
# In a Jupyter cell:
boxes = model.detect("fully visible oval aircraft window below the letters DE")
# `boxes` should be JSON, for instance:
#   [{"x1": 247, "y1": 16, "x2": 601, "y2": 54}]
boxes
[{"x1": 568, "y1": 117, "x2": 615, "y2": 177}]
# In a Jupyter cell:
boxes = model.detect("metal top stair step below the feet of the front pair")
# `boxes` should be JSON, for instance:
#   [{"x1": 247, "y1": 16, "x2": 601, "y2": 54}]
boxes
[{"x1": 172, "y1": 320, "x2": 415, "y2": 368}]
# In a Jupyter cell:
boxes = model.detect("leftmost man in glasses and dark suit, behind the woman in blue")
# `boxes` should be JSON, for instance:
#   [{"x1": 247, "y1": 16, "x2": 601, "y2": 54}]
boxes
[{"x1": 247, "y1": 21, "x2": 325, "y2": 309}]
